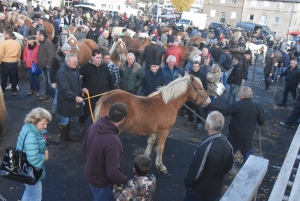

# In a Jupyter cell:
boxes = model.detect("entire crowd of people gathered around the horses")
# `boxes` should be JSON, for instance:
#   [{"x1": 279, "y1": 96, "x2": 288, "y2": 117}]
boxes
[{"x1": 0, "y1": 2, "x2": 300, "y2": 201}]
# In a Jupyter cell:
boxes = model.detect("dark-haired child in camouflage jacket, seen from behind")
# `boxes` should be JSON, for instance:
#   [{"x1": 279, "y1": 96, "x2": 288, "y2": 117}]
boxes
[{"x1": 114, "y1": 155, "x2": 156, "y2": 201}]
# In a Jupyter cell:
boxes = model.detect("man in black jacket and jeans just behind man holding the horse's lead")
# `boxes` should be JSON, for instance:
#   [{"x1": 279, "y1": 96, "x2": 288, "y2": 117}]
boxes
[{"x1": 227, "y1": 54, "x2": 243, "y2": 106}]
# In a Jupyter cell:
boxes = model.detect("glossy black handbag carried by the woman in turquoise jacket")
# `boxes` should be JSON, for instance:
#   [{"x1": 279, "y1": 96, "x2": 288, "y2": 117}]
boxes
[{"x1": 0, "y1": 131, "x2": 43, "y2": 185}]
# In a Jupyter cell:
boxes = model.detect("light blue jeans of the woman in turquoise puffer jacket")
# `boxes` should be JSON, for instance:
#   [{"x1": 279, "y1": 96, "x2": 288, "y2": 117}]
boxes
[{"x1": 22, "y1": 181, "x2": 42, "y2": 201}]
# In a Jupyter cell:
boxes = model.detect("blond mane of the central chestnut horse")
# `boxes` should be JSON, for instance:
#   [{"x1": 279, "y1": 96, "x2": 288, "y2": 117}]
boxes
[{"x1": 149, "y1": 75, "x2": 202, "y2": 104}]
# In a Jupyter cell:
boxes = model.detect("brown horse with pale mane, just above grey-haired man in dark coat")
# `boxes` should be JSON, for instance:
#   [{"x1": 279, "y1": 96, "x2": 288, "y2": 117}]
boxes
[{"x1": 67, "y1": 34, "x2": 98, "y2": 66}]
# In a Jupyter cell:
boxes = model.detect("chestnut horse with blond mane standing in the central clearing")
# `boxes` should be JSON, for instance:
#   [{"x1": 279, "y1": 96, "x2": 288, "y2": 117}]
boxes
[{"x1": 94, "y1": 75, "x2": 208, "y2": 174}]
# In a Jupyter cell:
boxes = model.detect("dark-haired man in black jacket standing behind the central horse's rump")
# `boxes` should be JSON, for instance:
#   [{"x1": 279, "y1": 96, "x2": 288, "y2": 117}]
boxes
[{"x1": 78, "y1": 49, "x2": 116, "y2": 133}]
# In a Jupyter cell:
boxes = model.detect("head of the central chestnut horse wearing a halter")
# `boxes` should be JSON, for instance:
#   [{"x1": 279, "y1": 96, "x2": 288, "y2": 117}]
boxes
[{"x1": 189, "y1": 75, "x2": 208, "y2": 105}]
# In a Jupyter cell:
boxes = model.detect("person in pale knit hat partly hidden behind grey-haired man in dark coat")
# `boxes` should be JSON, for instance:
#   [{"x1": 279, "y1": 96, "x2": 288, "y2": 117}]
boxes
[{"x1": 50, "y1": 43, "x2": 72, "y2": 116}]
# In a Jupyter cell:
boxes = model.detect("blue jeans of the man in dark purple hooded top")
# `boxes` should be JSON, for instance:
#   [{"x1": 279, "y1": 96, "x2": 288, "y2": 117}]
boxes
[{"x1": 90, "y1": 184, "x2": 115, "y2": 201}]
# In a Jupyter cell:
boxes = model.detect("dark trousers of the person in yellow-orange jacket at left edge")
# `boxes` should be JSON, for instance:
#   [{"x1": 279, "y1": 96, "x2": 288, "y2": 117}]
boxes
[{"x1": 1, "y1": 62, "x2": 19, "y2": 93}]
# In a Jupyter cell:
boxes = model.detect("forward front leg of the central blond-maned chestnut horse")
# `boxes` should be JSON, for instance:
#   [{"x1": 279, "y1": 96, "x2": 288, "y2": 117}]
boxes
[{"x1": 155, "y1": 130, "x2": 169, "y2": 174}]
